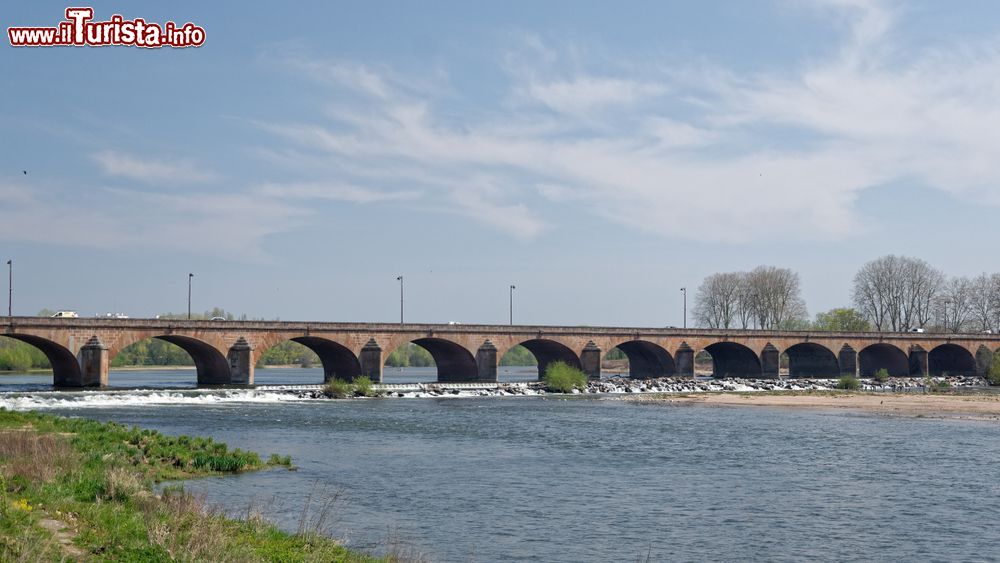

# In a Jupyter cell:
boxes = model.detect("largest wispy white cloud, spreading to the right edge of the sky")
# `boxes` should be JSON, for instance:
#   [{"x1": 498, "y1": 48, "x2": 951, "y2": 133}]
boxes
[{"x1": 256, "y1": 0, "x2": 1000, "y2": 242}]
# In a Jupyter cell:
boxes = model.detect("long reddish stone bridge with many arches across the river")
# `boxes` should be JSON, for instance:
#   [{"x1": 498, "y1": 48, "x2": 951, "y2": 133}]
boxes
[{"x1": 0, "y1": 317, "x2": 1000, "y2": 387}]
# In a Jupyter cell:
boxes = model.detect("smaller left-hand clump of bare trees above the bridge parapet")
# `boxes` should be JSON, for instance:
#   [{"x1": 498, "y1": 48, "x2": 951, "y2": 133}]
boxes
[{"x1": 694, "y1": 266, "x2": 807, "y2": 329}]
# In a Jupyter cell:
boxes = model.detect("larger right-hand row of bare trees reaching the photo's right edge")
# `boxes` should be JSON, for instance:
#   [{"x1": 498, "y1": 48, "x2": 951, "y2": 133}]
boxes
[{"x1": 853, "y1": 255, "x2": 1000, "y2": 332}]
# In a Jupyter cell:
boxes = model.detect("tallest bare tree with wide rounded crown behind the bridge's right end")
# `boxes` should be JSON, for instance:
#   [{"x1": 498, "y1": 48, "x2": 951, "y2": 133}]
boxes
[{"x1": 853, "y1": 255, "x2": 945, "y2": 331}]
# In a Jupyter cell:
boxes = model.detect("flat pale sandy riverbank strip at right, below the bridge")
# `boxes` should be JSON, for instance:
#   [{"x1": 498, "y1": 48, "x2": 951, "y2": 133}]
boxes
[{"x1": 628, "y1": 391, "x2": 1000, "y2": 422}]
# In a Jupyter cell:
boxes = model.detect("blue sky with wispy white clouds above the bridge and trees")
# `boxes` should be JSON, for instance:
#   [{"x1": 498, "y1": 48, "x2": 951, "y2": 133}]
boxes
[{"x1": 0, "y1": 0, "x2": 1000, "y2": 326}]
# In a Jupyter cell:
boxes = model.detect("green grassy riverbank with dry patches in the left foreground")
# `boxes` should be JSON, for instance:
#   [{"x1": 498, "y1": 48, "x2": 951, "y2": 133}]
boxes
[{"x1": 0, "y1": 409, "x2": 374, "y2": 561}]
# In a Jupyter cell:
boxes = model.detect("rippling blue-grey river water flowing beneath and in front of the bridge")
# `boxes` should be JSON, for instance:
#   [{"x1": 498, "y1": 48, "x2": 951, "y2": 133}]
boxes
[{"x1": 0, "y1": 370, "x2": 1000, "y2": 562}]
